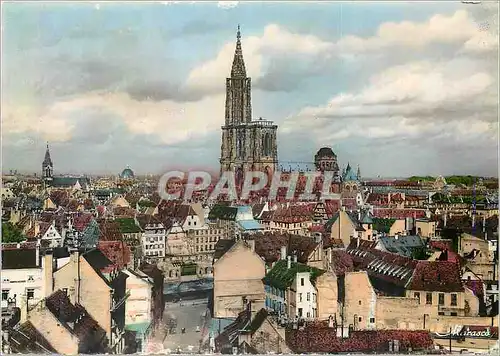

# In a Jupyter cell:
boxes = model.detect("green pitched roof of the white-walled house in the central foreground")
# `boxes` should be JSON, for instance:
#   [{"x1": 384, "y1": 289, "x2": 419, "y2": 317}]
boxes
[{"x1": 262, "y1": 260, "x2": 325, "y2": 290}]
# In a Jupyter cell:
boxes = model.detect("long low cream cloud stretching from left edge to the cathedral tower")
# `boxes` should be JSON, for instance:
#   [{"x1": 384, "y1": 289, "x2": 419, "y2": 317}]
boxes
[{"x1": 2, "y1": 93, "x2": 224, "y2": 144}]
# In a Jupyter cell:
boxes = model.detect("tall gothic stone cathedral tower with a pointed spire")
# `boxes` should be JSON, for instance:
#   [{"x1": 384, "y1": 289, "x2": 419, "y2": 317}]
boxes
[{"x1": 220, "y1": 26, "x2": 278, "y2": 184}]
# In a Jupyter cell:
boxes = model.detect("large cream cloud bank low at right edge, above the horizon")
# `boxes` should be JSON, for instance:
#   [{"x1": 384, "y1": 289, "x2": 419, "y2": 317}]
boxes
[{"x1": 281, "y1": 59, "x2": 498, "y2": 142}]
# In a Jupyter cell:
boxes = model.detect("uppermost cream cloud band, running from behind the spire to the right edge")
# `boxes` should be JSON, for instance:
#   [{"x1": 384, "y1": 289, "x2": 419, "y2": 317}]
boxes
[{"x1": 186, "y1": 10, "x2": 498, "y2": 93}]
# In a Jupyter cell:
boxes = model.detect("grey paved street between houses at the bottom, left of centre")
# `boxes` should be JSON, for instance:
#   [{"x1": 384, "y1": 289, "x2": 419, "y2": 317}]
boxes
[{"x1": 163, "y1": 299, "x2": 207, "y2": 353}]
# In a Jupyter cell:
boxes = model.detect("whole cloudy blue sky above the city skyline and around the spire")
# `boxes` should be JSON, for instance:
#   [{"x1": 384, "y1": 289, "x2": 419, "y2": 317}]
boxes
[{"x1": 2, "y1": 1, "x2": 498, "y2": 177}]
